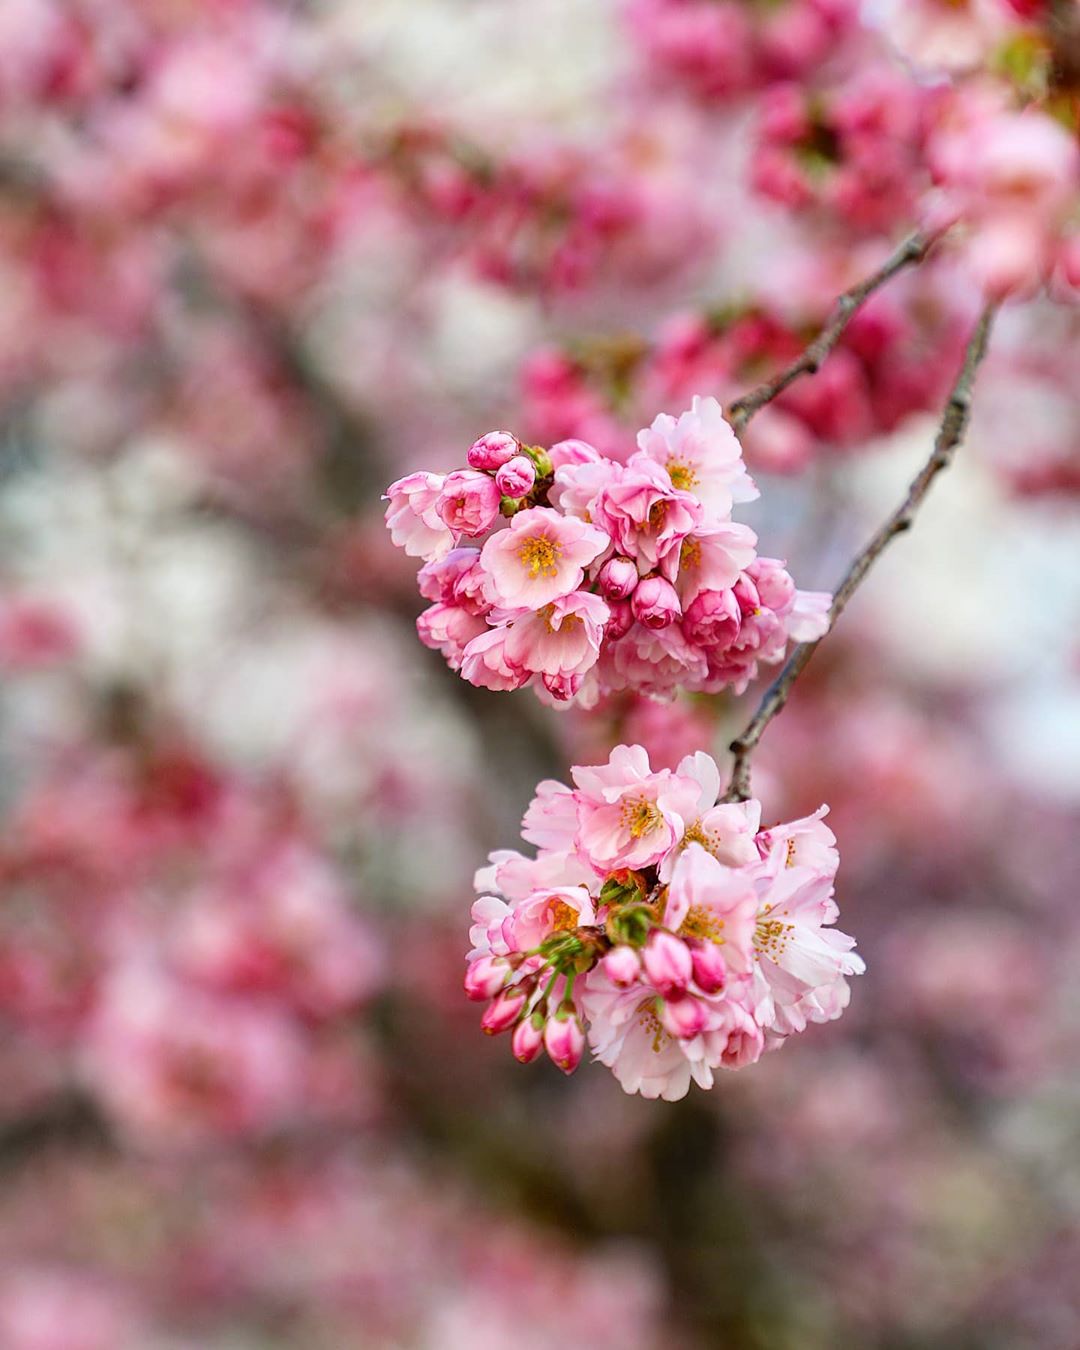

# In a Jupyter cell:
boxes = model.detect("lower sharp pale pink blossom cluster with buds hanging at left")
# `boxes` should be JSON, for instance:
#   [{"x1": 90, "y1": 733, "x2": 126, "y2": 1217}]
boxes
[{"x1": 464, "y1": 745, "x2": 864, "y2": 1100}]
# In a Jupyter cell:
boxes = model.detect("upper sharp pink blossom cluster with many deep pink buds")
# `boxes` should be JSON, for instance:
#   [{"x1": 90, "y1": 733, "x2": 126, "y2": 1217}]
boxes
[{"x1": 386, "y1": 398, "x2": 829, "y2": 706}]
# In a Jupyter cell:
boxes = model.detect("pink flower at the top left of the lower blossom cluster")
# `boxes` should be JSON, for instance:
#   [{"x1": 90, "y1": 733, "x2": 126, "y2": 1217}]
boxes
[{"x1": 571, "y1": 745, "x2": 698, "y2": 872}]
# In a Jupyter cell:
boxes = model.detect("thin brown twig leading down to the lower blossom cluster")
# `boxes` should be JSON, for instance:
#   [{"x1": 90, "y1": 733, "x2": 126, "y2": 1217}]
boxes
[{"x1": 724, "y1": 305, "x2": 995, "y2": 802}]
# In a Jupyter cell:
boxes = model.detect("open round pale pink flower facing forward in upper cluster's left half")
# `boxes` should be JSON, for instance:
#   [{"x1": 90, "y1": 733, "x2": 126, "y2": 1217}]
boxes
[{"x1": 481, "y1": 506, "x2": 609, "y2": 610}]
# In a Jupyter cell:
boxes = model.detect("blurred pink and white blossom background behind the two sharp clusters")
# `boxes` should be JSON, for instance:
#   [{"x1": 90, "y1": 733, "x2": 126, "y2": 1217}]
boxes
[{"x1": 0, "y1": 0, "x2": 1080, "y2": 1350}]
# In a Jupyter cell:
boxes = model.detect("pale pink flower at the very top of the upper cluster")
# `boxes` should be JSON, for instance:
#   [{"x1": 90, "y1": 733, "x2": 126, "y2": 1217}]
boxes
[{"x1": 629, "y1": 396, "x2": 760, "y2": 524}]
